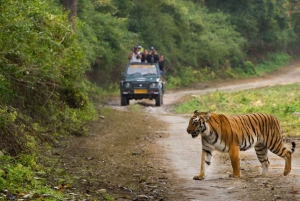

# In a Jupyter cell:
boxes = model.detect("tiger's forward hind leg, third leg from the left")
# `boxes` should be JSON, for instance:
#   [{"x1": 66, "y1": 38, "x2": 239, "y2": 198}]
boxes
[{"x1": 254, "y1": 143, "x2": 270, "y2": 175}]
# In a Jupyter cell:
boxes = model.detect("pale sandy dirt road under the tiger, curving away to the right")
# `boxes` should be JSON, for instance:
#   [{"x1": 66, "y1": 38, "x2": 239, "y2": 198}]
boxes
[{"x1": 138, "y1": 63, "x2": 300, "y2": 201}]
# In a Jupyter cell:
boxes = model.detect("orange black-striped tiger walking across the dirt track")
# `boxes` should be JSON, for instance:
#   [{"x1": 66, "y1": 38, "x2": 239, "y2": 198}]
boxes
[{"x1": 187, "y1": 110, "x2": 296, "y2": 180}]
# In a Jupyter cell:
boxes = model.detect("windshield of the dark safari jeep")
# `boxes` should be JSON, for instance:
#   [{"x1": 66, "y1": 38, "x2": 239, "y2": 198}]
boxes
[{"x1": 126, "y1": 64, "x2": 157, "y2": 76}]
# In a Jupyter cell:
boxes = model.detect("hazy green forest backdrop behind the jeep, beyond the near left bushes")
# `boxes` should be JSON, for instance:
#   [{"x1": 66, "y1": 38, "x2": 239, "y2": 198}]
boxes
[{"x1": 78, "y1": 0, "x2": 297, "y2": 87}]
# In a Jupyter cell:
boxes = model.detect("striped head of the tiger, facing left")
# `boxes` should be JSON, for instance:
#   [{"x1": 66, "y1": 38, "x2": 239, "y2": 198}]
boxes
[{"x1": 186, "y1": 110, "x2": 210, "y2": 138}]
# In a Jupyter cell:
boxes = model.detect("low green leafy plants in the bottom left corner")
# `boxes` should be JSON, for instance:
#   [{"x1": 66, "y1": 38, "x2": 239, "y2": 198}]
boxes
[{"x1": 0, "y1": 152, "x2": 63, "y2": 201}]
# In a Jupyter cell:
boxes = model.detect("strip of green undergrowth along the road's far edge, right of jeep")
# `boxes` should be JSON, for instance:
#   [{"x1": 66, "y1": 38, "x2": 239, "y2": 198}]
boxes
[{"x1": 166, "y1": 52, "x2": 292, "y2": 90}]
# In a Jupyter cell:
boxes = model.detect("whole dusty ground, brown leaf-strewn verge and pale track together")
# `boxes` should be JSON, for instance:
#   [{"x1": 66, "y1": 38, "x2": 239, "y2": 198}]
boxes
[{"x1": 54, "y1": 63, "x2": 300, "y2": 201}]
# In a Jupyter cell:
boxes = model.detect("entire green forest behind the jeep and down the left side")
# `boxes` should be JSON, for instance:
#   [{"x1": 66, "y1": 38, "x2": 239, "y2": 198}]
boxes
[{"x1": 0, "y1": 0, "x2": 300, "y2": 198}]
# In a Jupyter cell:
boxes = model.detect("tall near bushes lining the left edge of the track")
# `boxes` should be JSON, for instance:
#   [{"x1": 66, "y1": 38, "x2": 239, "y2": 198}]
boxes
[{"x1": 0, "y1": 0, "x2": 97, "y2": 197}]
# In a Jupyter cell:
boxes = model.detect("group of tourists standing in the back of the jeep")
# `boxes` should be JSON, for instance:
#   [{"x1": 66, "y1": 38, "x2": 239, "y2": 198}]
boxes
[{"x1": 128, "y1": 46, "x2": 165, "y2": 75}]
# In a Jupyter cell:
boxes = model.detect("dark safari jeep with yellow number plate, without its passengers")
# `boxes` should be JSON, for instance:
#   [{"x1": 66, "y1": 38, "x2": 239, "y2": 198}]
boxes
[{"x1": 120, "y1": 63, "x2": 165, "y2": 106}]
